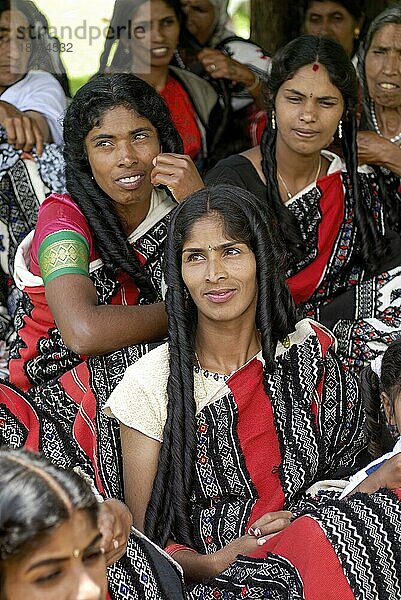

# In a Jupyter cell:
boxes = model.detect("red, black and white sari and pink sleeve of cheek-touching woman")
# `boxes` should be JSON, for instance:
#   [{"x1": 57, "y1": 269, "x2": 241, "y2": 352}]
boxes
[{"x1": 2, "y1": 190, "x2": 173, "y2": 497}]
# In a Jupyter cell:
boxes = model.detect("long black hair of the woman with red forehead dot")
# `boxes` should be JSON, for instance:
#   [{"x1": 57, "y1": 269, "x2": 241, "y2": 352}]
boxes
[{"x1": 260, "y1": 34, "x2": 386, "y2": 272}]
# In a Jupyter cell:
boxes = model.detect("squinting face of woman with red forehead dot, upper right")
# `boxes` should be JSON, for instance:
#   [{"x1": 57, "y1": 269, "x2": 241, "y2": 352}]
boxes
[{"x1": 275, "y1": 64, "x2": 344, "y2": 154}]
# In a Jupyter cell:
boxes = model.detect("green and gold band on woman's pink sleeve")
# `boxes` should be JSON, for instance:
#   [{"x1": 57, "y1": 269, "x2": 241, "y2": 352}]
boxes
[{"x1": 38, "y1": 231, "x2": 89, "y2": 285}]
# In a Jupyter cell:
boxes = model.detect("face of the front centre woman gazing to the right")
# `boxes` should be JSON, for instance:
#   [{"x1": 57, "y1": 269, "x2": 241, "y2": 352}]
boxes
[{"x1": 181, "y1": 213, "x2": 257, "y2": 323}]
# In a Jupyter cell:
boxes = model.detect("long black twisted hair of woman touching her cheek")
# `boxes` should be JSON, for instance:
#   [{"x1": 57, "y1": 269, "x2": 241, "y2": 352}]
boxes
[{"x1": 64, "y1": 73, "x2": 183, "y2": 301}]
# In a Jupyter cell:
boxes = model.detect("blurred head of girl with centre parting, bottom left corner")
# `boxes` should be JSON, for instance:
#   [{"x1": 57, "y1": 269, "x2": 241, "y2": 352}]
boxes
[{"x1": 0, "y1": 450, "x2": 110, "y2": 600}]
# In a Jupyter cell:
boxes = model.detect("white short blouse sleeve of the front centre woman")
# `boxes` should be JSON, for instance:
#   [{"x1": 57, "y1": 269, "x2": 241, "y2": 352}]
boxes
[{"x1": 103, "y1": 344, "x2": 169, "y2": 442}]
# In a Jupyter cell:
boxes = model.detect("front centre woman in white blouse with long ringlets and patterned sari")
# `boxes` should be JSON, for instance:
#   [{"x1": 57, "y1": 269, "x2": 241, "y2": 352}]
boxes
[{"x1": 106, "y1": 185, "x2": 399, "y2": 600}]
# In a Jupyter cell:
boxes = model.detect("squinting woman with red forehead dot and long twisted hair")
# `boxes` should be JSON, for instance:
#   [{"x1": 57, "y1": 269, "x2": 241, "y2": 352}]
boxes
[{"x1": 206, "y1": 35, "x2": 401, "y2": 368}]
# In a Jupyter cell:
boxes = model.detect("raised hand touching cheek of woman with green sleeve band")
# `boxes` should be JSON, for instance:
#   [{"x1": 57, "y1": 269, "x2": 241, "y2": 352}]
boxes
[{"x1": 150, "y1": 152, "x2": 205, "y2": 202}]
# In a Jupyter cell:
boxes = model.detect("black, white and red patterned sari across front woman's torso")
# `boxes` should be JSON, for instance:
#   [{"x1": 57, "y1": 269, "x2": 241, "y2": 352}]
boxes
[{"x1": 188, "y1": 320, "x2": 364, "y2": 558}]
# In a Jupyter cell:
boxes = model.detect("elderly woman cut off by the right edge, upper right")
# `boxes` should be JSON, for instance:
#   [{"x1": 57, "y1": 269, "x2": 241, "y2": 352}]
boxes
[{"x1": 358, "y1": 6, "x2": 401, "y2": 184}]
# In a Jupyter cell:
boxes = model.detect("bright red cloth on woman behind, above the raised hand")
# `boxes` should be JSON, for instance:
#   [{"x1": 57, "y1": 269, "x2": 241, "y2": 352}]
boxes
[{"x1": 160, "y1": 77, "x2": 202, "y2": 160}]
